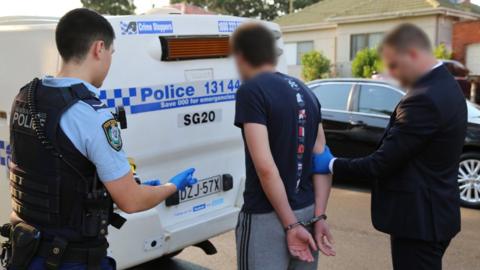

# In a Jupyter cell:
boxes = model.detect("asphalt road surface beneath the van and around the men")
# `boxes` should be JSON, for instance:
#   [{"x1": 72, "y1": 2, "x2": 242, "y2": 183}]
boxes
[{"x1": 134, "y1": 184, "x2": 480, "y2": 270}]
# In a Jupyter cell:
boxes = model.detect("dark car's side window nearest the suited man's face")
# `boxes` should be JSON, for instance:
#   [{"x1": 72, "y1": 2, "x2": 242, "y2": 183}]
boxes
[{"x1": 358, "y1": 84, "x2": 403, "y2": 116}]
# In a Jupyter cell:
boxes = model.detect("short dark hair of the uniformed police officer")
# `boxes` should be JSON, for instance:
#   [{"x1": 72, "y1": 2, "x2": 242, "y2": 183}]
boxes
[{"x1": 55, "y1": 8, "x2": 115, "y2": 62}]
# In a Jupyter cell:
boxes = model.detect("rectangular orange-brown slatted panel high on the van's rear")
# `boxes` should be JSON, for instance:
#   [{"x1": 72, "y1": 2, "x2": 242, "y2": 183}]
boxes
[{"x1": 160, "y1": 36, "x2": 230, "y2": 61}]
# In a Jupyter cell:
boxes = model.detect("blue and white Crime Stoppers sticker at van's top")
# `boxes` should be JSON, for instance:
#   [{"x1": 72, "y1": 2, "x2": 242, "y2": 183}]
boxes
[{"x1": 120, "y1": 21, "x2": 173, "y2": 35}]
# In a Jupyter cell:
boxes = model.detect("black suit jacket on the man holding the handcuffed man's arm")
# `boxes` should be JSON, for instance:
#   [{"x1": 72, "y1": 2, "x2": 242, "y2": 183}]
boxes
[{"x1": 333, "y1": 66, "x2": 467, "y2": 241}]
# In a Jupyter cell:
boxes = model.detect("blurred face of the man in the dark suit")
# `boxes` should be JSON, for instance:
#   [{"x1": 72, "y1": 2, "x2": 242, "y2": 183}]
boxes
[{"x1": 382, "y1": 46, "x2": 423, "y2": 87}]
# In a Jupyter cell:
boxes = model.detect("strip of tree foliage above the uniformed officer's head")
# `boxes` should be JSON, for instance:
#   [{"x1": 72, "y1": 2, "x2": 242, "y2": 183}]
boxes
[{"x1": 81, "y1": 0, "x2": 136, "y2": 15}]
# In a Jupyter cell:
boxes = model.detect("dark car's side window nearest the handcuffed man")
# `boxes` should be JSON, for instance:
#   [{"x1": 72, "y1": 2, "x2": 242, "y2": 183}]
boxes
[{"x1": 312, "y1": 83, "x2": 352, "y2": 111}]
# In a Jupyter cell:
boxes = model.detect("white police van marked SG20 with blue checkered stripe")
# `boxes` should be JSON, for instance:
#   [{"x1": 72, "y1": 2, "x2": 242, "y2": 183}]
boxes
[{"x1": 0, "y1": 12, "x2": 286, "y2": 268}]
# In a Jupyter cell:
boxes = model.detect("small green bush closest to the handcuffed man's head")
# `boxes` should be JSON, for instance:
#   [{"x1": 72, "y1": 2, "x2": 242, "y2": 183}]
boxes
[{"x1": 302, "y1": 51, "x2": 330, "y2": 81}]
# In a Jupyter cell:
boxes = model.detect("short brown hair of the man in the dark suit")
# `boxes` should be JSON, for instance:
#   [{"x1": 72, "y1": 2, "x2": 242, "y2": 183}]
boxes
[{"x1": 379, "y1": 23, "x2": 432, "y2": 52}]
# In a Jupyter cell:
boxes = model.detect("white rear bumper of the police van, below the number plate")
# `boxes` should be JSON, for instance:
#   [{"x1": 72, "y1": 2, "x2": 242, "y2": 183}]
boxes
[{"x1": 108, "y1": 206, "x2": 240, "y2": 269}]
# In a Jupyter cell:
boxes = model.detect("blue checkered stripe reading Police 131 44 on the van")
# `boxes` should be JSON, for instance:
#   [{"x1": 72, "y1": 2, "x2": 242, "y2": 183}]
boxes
[{"x1": 99, "y1": 79, "x2": 240, "y2": 114}]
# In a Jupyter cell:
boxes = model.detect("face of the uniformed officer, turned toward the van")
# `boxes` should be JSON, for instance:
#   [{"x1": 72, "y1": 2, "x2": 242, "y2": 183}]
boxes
[{"x1": 92, "y1": 40, "x2": 115, "y2": 87}]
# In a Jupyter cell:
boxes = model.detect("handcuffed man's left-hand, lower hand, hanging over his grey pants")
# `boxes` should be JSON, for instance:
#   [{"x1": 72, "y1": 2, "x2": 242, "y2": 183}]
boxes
[{"x1": 287, "y1": 226, "x2": 317, "y2": 262}]
